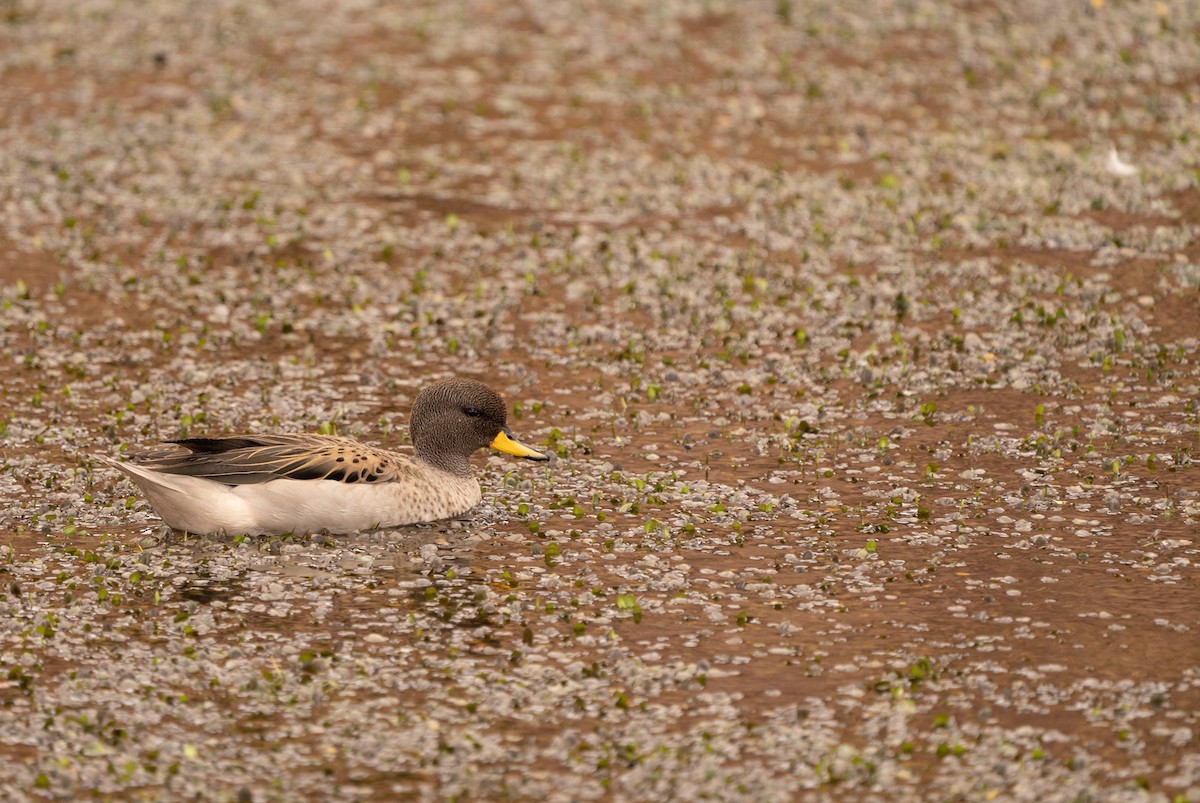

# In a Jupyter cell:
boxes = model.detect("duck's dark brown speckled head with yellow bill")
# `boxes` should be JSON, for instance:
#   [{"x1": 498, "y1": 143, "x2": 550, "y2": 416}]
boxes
[{"x1": 408, "y1": 378, "x2": 550, "y2": 474}]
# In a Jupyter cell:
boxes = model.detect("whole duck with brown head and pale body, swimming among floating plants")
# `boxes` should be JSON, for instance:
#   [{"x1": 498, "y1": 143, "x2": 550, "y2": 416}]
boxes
[{"x1": 102, "y1": 378, "x2": 550, "y2": 535}]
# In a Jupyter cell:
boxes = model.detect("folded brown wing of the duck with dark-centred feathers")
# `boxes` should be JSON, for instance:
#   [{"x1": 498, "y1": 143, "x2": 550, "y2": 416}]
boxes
[{"x1": 142, "y1": 435, "x2": 412, "y2": 485}]
